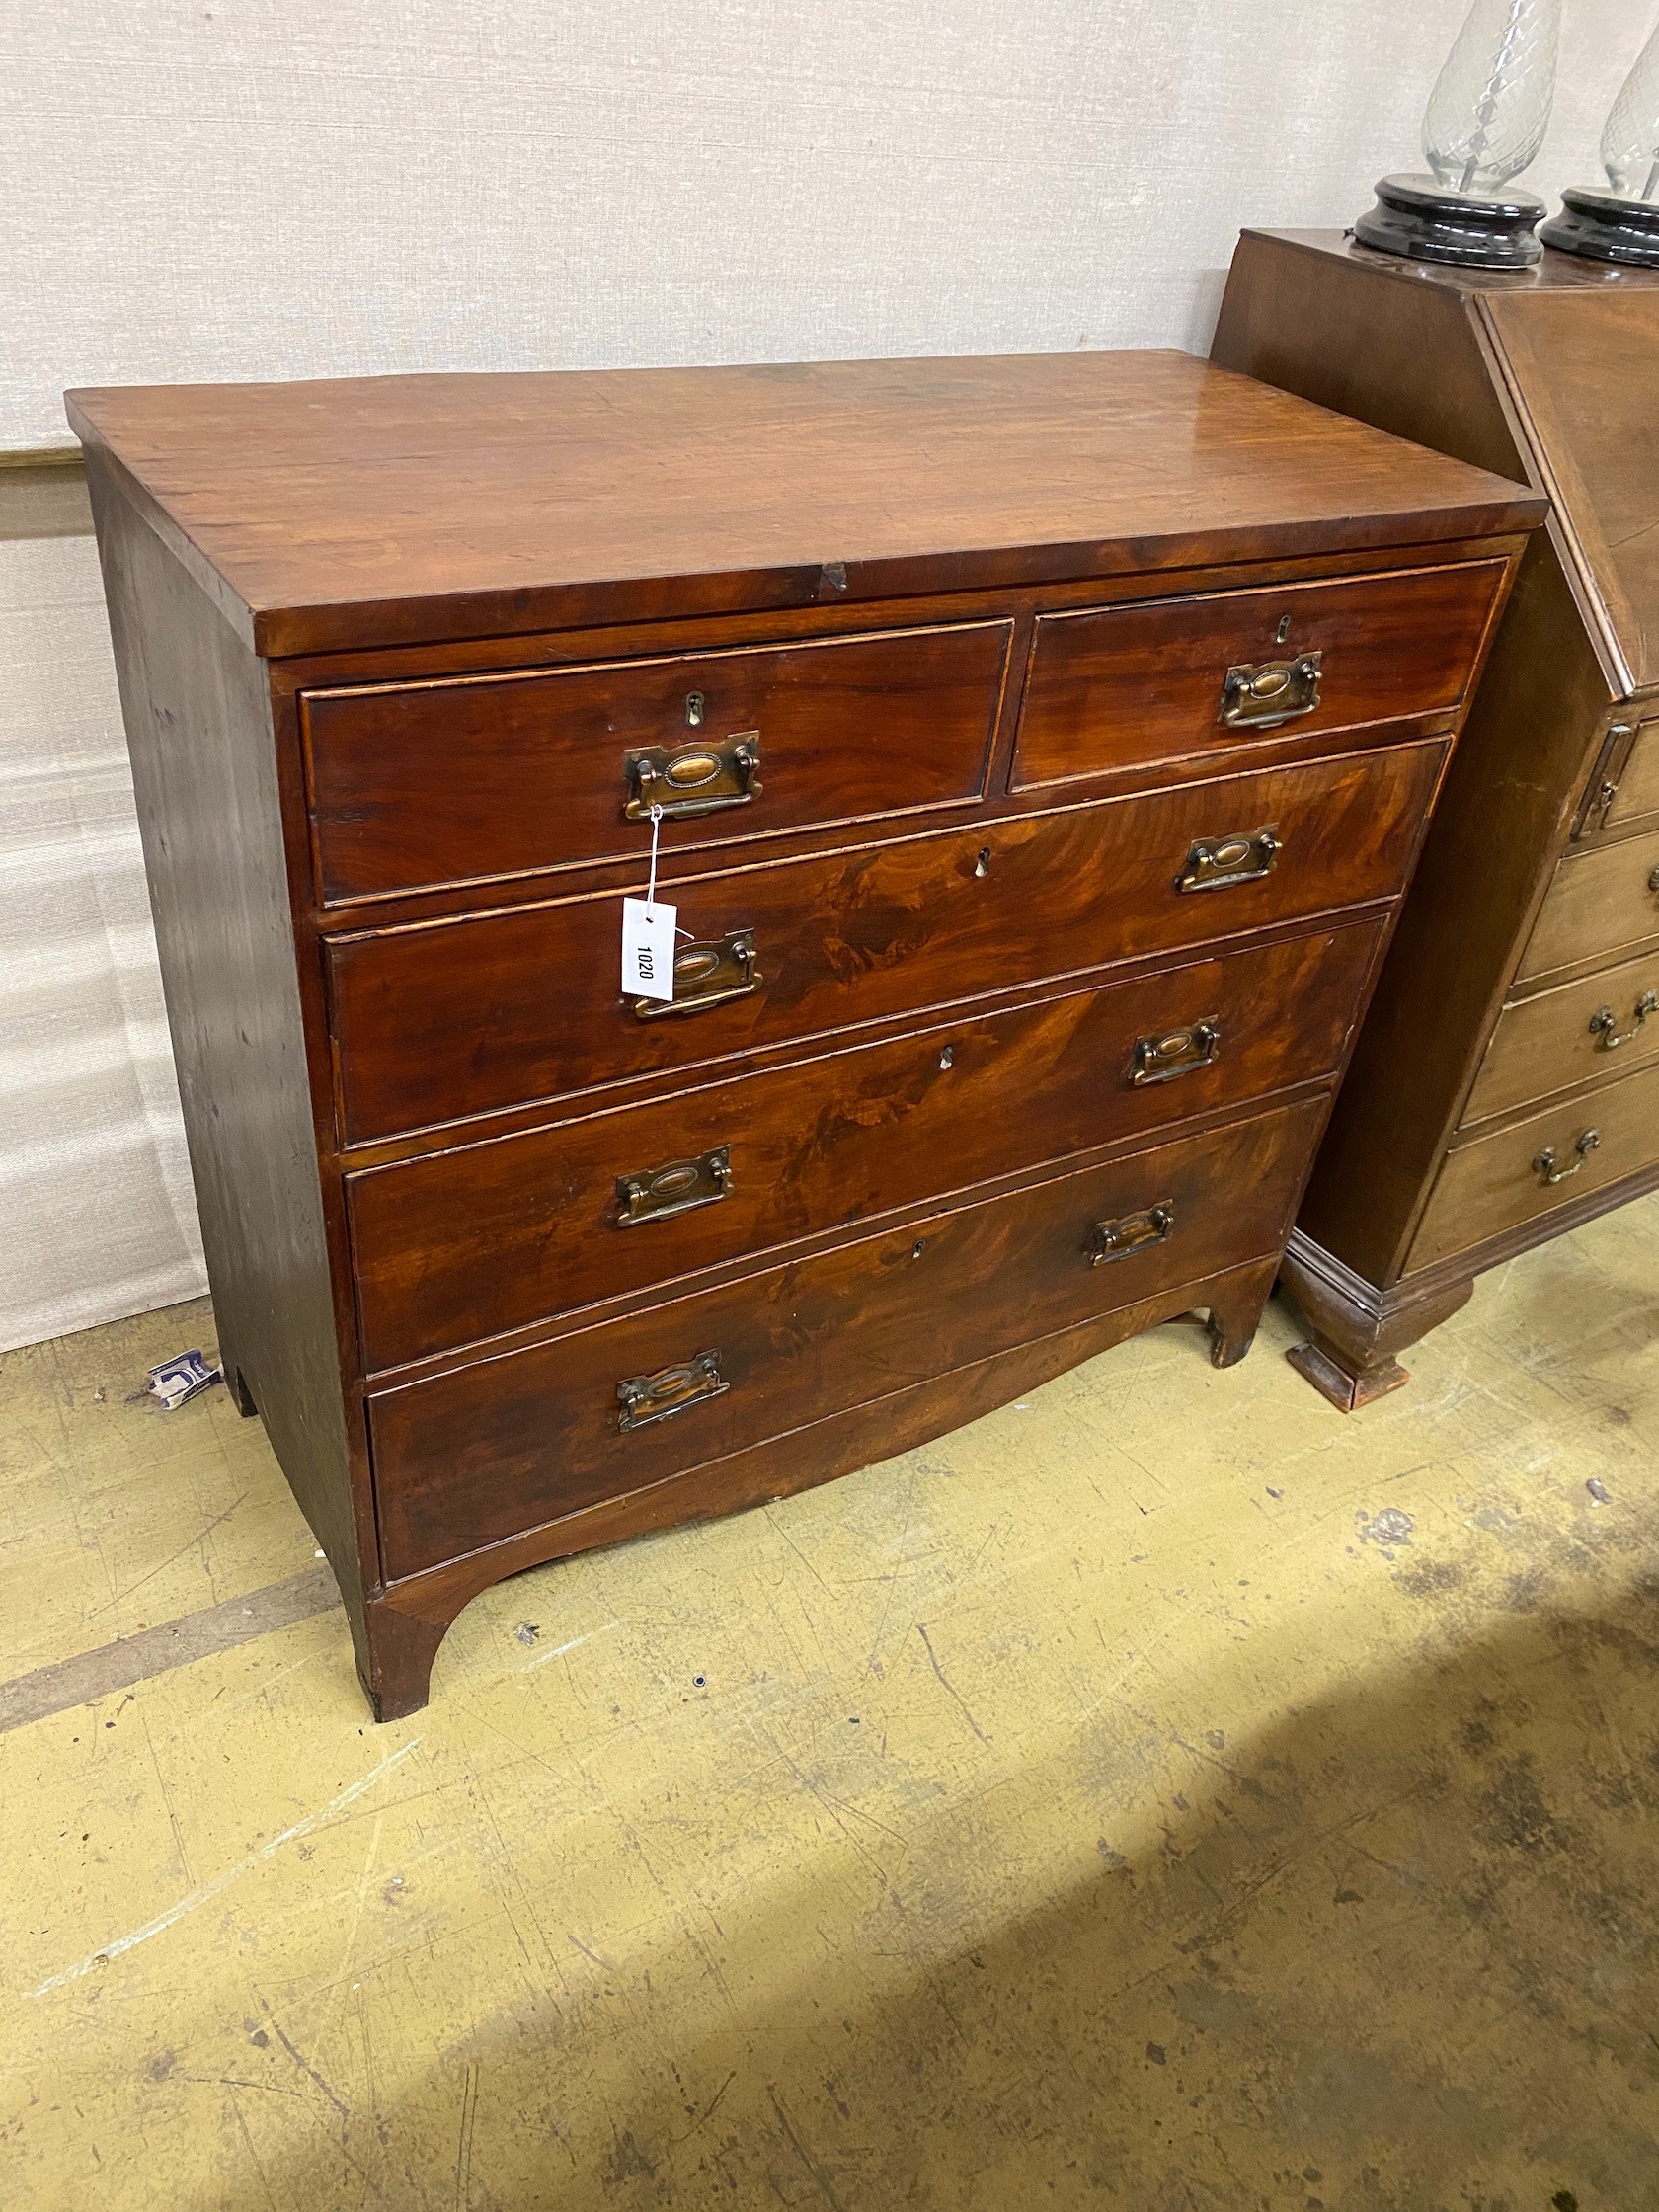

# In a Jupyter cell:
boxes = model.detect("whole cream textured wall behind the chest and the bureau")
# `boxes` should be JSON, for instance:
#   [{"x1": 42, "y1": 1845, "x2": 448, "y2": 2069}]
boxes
[{"x1": 0, "y1": 0, "x2": 1652, "y2": 1345}]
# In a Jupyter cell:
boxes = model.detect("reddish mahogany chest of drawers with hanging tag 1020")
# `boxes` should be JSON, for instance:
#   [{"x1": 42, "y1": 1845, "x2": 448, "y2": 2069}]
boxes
[{"x1": 71, "y1": 354, "x2": 1544, "y2": 1716}]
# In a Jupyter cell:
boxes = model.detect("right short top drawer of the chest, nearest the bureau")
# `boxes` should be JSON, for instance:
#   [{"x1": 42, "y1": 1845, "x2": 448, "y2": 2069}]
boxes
[{"x1": 1013, "y1": 562, "x2": 1504, "y2": 790}]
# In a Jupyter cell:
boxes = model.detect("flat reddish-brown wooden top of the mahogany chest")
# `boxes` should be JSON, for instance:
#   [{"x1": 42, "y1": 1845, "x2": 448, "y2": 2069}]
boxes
[{"x1": 68, "y1": 352, "x2": 1541, "y2": 657}]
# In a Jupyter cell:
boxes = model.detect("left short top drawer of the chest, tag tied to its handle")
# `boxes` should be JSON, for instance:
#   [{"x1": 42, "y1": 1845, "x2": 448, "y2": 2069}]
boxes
[{"x1": 301, "y1": 621, "x2": 1011, "y2": 905}]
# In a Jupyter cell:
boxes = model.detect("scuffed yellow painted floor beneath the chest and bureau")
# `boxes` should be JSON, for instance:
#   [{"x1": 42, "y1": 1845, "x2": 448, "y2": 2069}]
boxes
[{"x1": 0, "y1": 1199, "x2": 1659, "y2": 2212}]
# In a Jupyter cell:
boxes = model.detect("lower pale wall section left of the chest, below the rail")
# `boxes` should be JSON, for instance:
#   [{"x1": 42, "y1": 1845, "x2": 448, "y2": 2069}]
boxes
[{"x1": 0, "y1": 537, "x2": 203, "y2": 1345}]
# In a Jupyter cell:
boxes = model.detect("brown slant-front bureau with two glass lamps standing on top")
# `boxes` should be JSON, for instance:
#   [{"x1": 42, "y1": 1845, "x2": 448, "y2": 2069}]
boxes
[{"x1": 1215, "y1": 232, "x2": 1659, "y2": 1409}]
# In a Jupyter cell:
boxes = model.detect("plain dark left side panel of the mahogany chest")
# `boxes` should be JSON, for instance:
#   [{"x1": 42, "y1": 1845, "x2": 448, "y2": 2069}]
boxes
[{"x1": 89, "y1": 455, "x2": 376, "y2": 1625}]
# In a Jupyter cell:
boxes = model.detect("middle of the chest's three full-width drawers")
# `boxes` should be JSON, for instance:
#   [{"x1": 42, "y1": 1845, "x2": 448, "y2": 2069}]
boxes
[{"x1": 345, "y1": 920, "x2": 1382, "y2": 1367}]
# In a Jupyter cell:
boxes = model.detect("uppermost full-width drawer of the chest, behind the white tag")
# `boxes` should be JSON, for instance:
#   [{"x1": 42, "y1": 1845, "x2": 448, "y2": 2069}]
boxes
[{"x1": 325, "y1": 739, "x2": 1447, "y2": 1144}]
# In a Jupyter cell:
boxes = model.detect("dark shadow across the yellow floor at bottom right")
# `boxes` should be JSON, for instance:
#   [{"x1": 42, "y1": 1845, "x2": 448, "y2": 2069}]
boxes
[{"x1": 260, "y1": 1486, "x2": 1659, "y2": 2212}]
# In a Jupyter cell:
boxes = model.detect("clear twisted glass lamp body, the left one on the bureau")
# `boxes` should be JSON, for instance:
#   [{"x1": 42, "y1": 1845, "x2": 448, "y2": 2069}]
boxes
[{"x1": 1422, "y1": 0, "x2": 1561, "y2": 199}]
